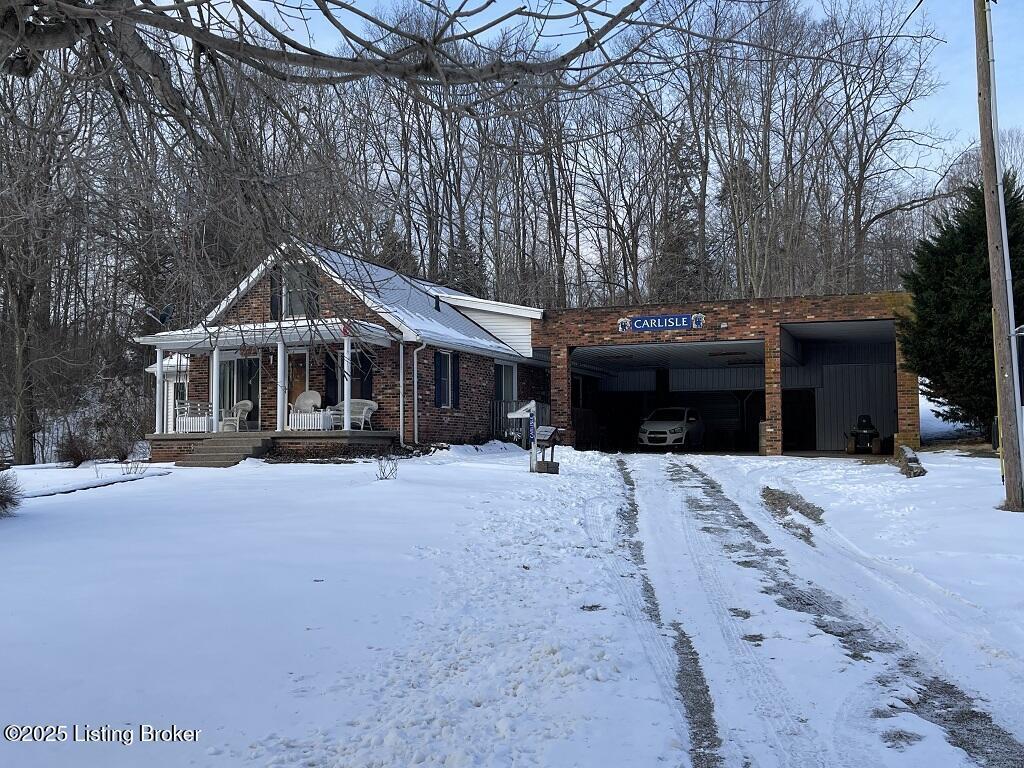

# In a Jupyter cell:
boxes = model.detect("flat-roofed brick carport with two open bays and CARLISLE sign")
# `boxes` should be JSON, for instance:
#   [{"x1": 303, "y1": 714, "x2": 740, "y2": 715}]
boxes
[{"x1": 531, "y1": 293, "x2": 921, "y2": 455}]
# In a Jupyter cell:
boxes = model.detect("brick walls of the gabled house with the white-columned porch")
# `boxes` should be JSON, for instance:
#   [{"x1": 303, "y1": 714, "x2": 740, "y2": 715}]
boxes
[{"x1": 144, "y1": 247, "x2": 546, "y2": 460}]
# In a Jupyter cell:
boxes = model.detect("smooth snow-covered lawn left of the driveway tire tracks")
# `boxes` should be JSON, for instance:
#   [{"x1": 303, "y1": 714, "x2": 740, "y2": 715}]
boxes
[{"x1": 0, "y1": 449, "x2": 681, "y2": 768}]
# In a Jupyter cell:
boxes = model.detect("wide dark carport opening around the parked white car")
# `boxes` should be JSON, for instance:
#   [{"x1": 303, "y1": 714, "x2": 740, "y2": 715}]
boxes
[{"x1": 570, "y1": 339, "x2": 765, "y2": 453}]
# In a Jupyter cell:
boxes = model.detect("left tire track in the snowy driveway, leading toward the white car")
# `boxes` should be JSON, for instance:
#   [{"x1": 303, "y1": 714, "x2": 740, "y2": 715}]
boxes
[{"x1": 584, "y1": 459, "x2": 723, "y2": 768}]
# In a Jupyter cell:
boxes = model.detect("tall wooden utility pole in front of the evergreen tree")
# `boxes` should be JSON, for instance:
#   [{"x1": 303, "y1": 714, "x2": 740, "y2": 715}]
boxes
[{"x1": 974, "y1": 0, "x2": 1024, "y2": 511}]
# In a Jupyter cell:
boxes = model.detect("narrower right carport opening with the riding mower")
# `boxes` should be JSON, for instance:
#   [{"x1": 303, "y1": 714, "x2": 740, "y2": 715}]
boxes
[{"x1": 781, "y1": 319, "x2": 897, "y2": 454}]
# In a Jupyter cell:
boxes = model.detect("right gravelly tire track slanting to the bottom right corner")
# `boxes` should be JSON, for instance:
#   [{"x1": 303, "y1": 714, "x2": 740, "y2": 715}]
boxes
[{"x1": 670, "y1": 463, "x2": 1024, "y2": 768}]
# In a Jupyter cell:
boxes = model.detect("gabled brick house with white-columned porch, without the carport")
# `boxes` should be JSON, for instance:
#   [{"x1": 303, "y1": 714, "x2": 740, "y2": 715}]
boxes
[{"x1": 137, "y1": 245, "x2": 547, "y2": 464}]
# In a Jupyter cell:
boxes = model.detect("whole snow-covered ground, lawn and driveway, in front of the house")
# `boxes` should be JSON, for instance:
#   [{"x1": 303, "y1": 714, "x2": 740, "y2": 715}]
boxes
[{"x1": 0, "y1": 445, "x2": 1024, "y2": 768}]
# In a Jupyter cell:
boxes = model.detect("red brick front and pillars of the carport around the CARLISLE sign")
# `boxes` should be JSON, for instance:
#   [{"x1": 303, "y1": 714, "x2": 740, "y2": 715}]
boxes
[{"x1": 532, "y1": 293, "x2": 921, "y2": 454}]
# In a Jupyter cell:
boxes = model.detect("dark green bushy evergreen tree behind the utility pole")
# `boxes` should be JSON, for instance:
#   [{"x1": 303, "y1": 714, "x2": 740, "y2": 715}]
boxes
[{"x1": 898, "y1": 174, "x2": 1024, "y2": 434}]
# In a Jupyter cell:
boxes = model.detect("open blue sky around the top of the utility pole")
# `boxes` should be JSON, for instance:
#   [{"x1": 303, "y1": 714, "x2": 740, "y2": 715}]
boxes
[{"x1": 913, "y1": 0, "x2": 1024, "y2": 143}]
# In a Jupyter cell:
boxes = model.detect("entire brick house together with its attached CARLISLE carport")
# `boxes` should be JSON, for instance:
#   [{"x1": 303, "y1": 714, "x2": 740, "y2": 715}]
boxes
[{"x1": 138, "y1": 246, "x2": 921, "y2": 464}]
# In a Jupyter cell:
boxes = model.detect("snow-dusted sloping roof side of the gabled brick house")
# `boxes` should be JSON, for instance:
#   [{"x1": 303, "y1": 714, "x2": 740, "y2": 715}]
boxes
[{"x1": 309, "y1": 248, "x2": 522, "y2": 357}]
